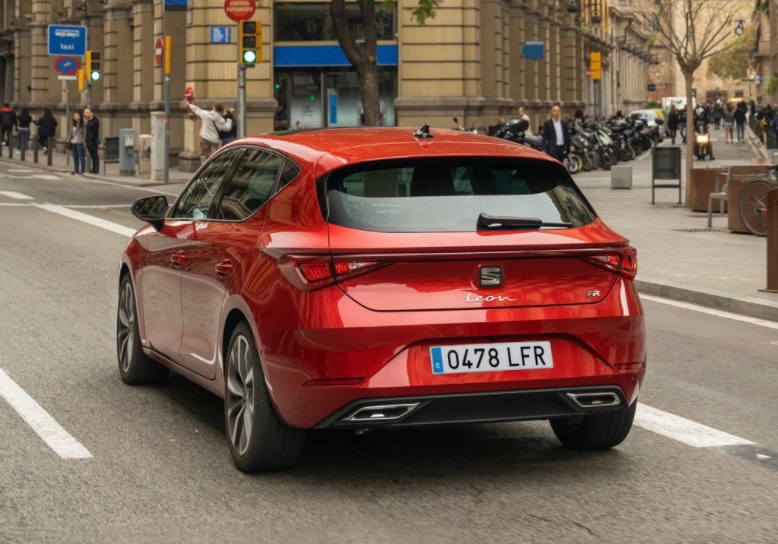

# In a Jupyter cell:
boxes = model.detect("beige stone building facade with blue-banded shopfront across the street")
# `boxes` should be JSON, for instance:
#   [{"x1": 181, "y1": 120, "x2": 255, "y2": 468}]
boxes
[{"x1": 0, "y1": 0, "x2": 657, "y2": 170}]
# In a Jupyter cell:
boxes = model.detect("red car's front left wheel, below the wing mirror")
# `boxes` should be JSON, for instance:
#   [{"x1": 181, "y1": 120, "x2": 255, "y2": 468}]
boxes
[{"x1": 116, "y1": 274, "x2": 170, "y2": 385}]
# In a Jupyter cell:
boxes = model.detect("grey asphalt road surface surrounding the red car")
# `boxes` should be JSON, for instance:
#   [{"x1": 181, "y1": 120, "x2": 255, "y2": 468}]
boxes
[{"x1": 0, "y1": 164, "x2": 778, "y2": 544}]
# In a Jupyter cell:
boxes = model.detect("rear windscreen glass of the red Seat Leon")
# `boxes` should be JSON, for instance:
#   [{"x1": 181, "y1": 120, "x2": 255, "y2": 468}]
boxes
[{"x1": 326, "y1": 158, "x2": 596, "y2": 232}]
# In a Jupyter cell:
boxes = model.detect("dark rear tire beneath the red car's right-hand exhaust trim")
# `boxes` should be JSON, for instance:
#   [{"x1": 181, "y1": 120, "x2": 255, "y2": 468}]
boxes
[{"x1": 550, "y1": 401, "x2": 638, "y2": 450}]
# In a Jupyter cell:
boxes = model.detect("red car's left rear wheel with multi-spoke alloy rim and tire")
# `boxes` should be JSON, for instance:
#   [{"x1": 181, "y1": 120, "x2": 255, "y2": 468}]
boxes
[{"x1": 224, "y1": 321, "x2": 305, "y2": 472}]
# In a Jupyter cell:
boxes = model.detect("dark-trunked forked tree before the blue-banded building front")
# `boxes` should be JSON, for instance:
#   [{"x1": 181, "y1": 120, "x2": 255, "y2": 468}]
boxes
[{"x1": 330, "y1": 0, "x2": 438, "y2": 127}]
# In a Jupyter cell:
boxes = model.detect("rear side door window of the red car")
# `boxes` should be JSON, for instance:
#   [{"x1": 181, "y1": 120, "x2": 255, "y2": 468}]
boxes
[{"x1": 213, "y1": 149, "x2": 283, "y2": 221}]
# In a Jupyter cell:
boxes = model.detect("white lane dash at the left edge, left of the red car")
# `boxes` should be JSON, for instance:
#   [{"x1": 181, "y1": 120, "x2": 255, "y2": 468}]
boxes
[{"x1": 0, "y1": 368, "x2": 92, "y2": 459}]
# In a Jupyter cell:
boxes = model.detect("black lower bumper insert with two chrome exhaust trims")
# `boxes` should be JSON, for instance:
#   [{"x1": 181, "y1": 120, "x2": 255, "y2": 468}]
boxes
[{"x1": 316, "y1": 386, "x2": 628, "y2": 429}]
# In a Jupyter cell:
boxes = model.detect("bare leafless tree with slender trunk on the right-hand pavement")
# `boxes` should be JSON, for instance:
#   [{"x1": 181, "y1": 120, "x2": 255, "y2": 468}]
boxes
[{"x1": 639, "y1": 0, "x2": 752, "y2": 202}]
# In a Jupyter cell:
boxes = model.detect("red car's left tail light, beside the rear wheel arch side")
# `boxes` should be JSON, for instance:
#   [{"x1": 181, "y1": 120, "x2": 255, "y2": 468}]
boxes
[{"x1": 264, "y1": 251, "x2": 388, "y2": 291}]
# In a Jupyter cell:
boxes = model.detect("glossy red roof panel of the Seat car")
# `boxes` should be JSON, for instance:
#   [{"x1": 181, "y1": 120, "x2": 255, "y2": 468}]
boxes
[{"x1": 230, "y1": 128, "x2": 551, "y2": 170}]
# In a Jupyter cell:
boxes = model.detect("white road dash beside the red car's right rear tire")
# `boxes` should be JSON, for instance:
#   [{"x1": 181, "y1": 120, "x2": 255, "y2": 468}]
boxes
[{"x1": 635, "y1": 403, "x2": 753, "y2": 448}]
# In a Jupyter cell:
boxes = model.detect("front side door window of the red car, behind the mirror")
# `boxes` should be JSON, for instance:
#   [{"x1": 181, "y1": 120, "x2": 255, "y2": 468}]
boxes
[{"x1": 170, "y1": 149, "x2": 242, "y2": 219}]
